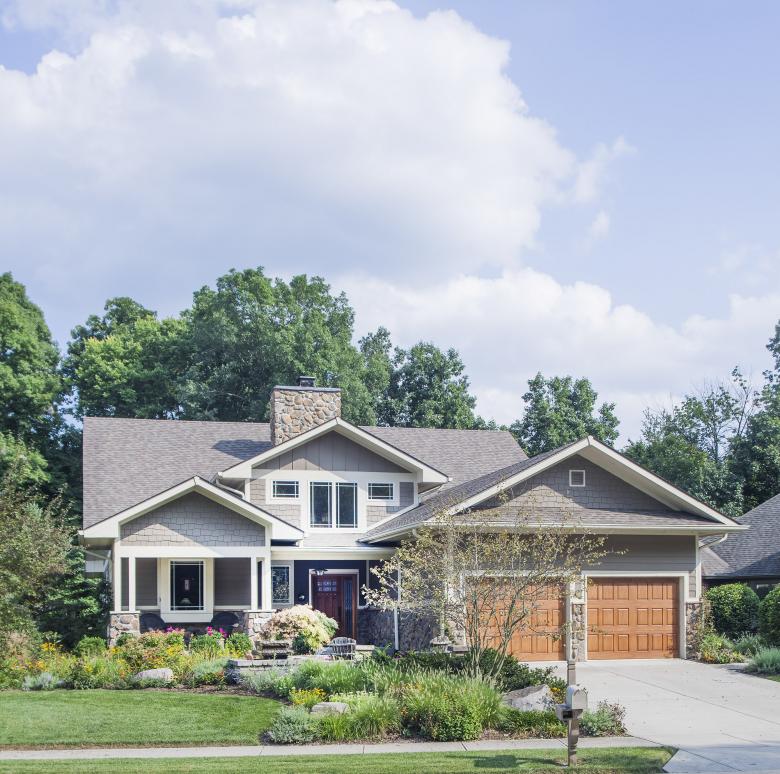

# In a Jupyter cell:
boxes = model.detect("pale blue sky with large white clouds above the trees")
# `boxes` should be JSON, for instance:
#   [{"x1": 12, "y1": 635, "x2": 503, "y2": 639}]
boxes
[{"x1": 0, "y1": 0, "x2": 780, "y2": 442}]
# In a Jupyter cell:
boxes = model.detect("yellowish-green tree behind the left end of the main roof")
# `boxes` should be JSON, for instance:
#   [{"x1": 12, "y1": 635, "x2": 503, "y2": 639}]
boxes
[{"x1": 64, "y1": 298, "x2": 186, "y2": 419}]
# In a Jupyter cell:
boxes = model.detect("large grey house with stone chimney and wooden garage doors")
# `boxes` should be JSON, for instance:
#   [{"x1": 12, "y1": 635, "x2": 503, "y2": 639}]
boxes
[{"x1": 80, "y1": 377, "x2": 745, "y2": 660}]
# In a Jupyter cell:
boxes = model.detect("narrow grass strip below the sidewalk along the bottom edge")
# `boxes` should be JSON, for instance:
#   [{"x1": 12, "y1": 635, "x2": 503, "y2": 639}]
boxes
[{"x1": 0, "y1": 747, "x2": 673, "y2": 774}]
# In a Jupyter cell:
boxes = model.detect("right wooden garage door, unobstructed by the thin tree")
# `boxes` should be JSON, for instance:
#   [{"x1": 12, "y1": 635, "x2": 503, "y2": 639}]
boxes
[{"x1": 588, "y1": 578, "x2": 680, "y2": 659}]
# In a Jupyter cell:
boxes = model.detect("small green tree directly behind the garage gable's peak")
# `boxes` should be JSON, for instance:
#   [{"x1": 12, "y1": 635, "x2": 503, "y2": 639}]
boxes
[{"x1": 509, "y1": 373, "x2": 620, "y2": 457}]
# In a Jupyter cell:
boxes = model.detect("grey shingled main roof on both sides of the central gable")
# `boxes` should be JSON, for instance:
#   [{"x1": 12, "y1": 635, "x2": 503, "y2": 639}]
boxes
[{"x1": 84, "y1": 417, "x2": 526, "y2": 527}]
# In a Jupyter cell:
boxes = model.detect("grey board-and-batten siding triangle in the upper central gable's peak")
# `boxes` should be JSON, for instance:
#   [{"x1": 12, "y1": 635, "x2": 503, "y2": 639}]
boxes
[{"x1": 256, "y1": 433, "x2": 408, "y2": 473}]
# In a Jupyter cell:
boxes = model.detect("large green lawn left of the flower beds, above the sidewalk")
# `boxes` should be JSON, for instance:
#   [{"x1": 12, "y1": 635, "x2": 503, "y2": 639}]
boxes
[{"x1": 0, "y1": 690, "x2": 280, "y2": 747}]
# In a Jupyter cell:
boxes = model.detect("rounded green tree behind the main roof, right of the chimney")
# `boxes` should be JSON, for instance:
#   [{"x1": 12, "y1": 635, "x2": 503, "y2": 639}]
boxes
[{"x1": 379, "y1": 342, "x2": 476, "y2": 428}]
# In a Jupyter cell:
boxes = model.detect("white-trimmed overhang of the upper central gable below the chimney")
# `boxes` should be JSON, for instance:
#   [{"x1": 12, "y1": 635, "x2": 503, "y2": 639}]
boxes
[{"x1": 218, "y1": 417, "x2": 450, "y2": 484}]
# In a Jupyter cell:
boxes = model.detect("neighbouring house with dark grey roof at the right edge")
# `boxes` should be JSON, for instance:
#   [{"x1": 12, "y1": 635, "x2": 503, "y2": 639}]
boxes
[{"x1": 702, "y1": 494, "x2": 780, "y2": 597}]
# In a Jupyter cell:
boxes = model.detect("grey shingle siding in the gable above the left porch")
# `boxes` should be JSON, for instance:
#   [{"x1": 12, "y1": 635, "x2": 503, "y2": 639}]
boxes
[{"x1": 121, "y1": 494, "x2": 265, "y2": 546}]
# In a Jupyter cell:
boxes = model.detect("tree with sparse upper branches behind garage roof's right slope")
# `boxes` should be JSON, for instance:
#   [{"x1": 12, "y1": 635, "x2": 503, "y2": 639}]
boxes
[{"x1": 625, "y1": 368, "x2": 755, "y2": 516}]
